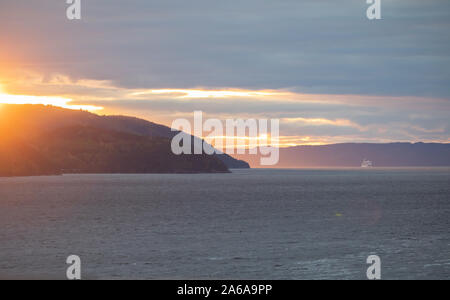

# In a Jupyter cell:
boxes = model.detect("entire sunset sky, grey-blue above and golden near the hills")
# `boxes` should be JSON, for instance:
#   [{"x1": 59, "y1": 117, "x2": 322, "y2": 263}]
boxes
[{"x1": 0, "y1": 0, "x2": 450, "y2": 146}]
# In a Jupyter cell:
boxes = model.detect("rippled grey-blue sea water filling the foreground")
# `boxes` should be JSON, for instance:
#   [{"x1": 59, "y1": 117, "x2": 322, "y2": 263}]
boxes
[{"x1": 0, "y1": 168, "x2": 450, "y2": 279}]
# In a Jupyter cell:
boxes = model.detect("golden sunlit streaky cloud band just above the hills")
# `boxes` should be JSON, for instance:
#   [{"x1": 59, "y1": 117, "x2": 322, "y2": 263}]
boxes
[{"x1": 0, "y1": 73, "x2": 449, "y2": 145}]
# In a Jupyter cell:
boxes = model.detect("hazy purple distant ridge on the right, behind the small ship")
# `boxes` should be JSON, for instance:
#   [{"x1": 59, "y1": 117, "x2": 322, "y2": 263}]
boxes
[{"x1": 235, "y1": 143, "x2": 450, "y2": 168}]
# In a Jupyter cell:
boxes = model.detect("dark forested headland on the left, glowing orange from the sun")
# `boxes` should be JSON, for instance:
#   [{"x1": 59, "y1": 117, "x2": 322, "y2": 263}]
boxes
[{"x1": 0, "y1": 105, "x2": 249, "y2": 176}]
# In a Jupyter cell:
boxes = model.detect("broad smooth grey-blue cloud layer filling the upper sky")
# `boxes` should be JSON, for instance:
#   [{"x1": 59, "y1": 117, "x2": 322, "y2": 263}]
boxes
[{"x1": 0, "y1": 0, "x2": 450, "y2": 98}]
